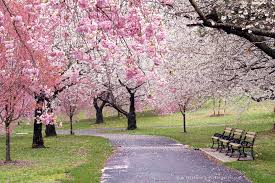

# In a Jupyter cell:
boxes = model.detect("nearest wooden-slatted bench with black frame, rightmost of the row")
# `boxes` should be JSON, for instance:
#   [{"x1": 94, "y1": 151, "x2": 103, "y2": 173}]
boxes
[{"x1": 229, "y1": 132, "x2": 257, "y2": 160}]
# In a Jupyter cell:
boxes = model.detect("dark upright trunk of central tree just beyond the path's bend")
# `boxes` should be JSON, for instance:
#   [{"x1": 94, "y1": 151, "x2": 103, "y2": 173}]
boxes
[{"x1": 127, "y1": 93, "x2": 137, "y2": 130}]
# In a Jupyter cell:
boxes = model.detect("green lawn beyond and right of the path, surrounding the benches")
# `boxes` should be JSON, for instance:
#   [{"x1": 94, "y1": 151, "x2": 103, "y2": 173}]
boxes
[{"x1": 11, "y1": 102, "x2": 275, "y2": 183}]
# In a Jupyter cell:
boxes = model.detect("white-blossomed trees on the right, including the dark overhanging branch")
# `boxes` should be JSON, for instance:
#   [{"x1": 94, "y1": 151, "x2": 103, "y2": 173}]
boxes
[{"x1": 152, "y1": 0, "x2": 275, "y2": 132}]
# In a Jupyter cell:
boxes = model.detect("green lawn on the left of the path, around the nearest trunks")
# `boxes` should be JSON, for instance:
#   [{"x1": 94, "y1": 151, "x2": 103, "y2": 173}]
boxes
[{"x1": 0, "y1": 135, "x2": 112, "y2": 183}]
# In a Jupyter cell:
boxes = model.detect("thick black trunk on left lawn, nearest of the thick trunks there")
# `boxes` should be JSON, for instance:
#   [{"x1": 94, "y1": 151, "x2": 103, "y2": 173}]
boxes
[{"x1": 32, "y1": 108, "x2": 45, "y2": 148}]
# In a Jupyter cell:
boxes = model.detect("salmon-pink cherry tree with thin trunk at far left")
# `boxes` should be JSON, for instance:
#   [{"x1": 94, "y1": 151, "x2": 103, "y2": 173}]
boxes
[{"x1": 0, "y1": 0, "x2": 63, "y2": 161}]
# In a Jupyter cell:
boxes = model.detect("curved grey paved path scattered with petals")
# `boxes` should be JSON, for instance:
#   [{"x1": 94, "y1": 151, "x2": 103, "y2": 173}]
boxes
[{"x1": 59, "y1": 130, "x2": 249, "y2": 183}]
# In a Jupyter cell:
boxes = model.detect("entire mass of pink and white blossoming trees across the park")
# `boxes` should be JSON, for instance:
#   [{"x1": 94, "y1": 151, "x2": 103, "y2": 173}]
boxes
[{"x1": 0, "y1": 0, "x2": 275, "y2": 161}]
